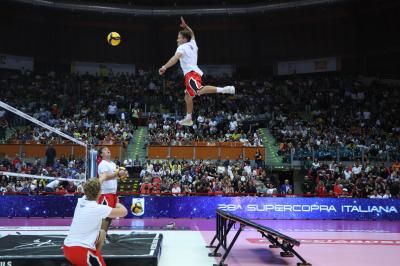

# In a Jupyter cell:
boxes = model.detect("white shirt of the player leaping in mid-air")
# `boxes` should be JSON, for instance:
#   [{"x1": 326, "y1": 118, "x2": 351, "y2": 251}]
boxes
[{"x1": 175, "y1": 38, "x2": 203, "y2": 76}]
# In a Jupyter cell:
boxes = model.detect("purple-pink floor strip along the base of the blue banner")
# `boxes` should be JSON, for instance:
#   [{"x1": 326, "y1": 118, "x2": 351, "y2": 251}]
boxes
[{"x1": 0, "y1": 218, "x2": 400, "y2": 233}]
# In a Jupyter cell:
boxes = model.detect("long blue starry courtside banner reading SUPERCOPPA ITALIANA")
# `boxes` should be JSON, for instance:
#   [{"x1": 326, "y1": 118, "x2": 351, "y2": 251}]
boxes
[{"x1": 0, "y1": 196, "x2": 400, "y2": 220}]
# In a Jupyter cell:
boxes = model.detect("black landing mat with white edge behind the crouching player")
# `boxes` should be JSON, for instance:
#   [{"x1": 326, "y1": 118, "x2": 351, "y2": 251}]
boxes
[{"x1": 0, "y1": 233, "x2": 163, "y2": 266}]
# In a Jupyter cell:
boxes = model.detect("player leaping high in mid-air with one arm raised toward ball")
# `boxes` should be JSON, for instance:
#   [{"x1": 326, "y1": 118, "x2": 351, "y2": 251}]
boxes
[{"x1": 158, "y1": 17, "x2": 235, "y2": 126}]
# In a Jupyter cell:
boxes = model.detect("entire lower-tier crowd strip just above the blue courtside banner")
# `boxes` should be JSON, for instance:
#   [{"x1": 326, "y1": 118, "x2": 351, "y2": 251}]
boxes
[{"x1": 0, "y1": 151, "x2": 400, "y2": 198}]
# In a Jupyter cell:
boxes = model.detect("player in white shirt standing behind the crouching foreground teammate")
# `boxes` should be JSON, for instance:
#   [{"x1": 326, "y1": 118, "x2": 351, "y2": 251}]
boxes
[{"x1": 97, "y1": 147, "x2": 125, "y2": 232}]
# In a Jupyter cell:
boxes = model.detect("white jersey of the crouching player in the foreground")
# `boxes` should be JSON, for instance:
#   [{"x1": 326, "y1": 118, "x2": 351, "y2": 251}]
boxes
[{"x1": 64, "y1": 196, "x2": 112, "y2": 249}]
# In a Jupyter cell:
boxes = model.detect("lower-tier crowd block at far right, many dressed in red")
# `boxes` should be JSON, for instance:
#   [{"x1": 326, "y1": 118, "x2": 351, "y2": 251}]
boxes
[{"x1": 301, "y1": 159, "x2": 400, "y2": 199}]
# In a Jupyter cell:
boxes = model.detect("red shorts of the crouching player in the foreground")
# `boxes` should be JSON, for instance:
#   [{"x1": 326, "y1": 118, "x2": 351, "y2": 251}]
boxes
[{"x1": 63, "y1": 246, "x2": 106, "y2": 266}]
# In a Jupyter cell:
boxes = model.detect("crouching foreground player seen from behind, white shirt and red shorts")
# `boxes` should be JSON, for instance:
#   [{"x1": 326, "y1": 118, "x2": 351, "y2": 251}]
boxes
[{"x1": 63, "y1": 179, "x2": 128, "y2": 266}]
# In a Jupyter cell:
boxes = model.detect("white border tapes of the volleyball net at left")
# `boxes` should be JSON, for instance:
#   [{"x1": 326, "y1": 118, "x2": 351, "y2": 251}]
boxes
[{"x1": 0, "y1": 101, "x2": 88, "y2": 181}]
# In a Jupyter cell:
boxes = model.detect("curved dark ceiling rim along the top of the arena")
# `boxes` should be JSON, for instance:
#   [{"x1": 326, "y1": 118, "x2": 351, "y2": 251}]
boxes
[{"x1": 8, "y1": 0, "x2": 359, "y2": 16}]
